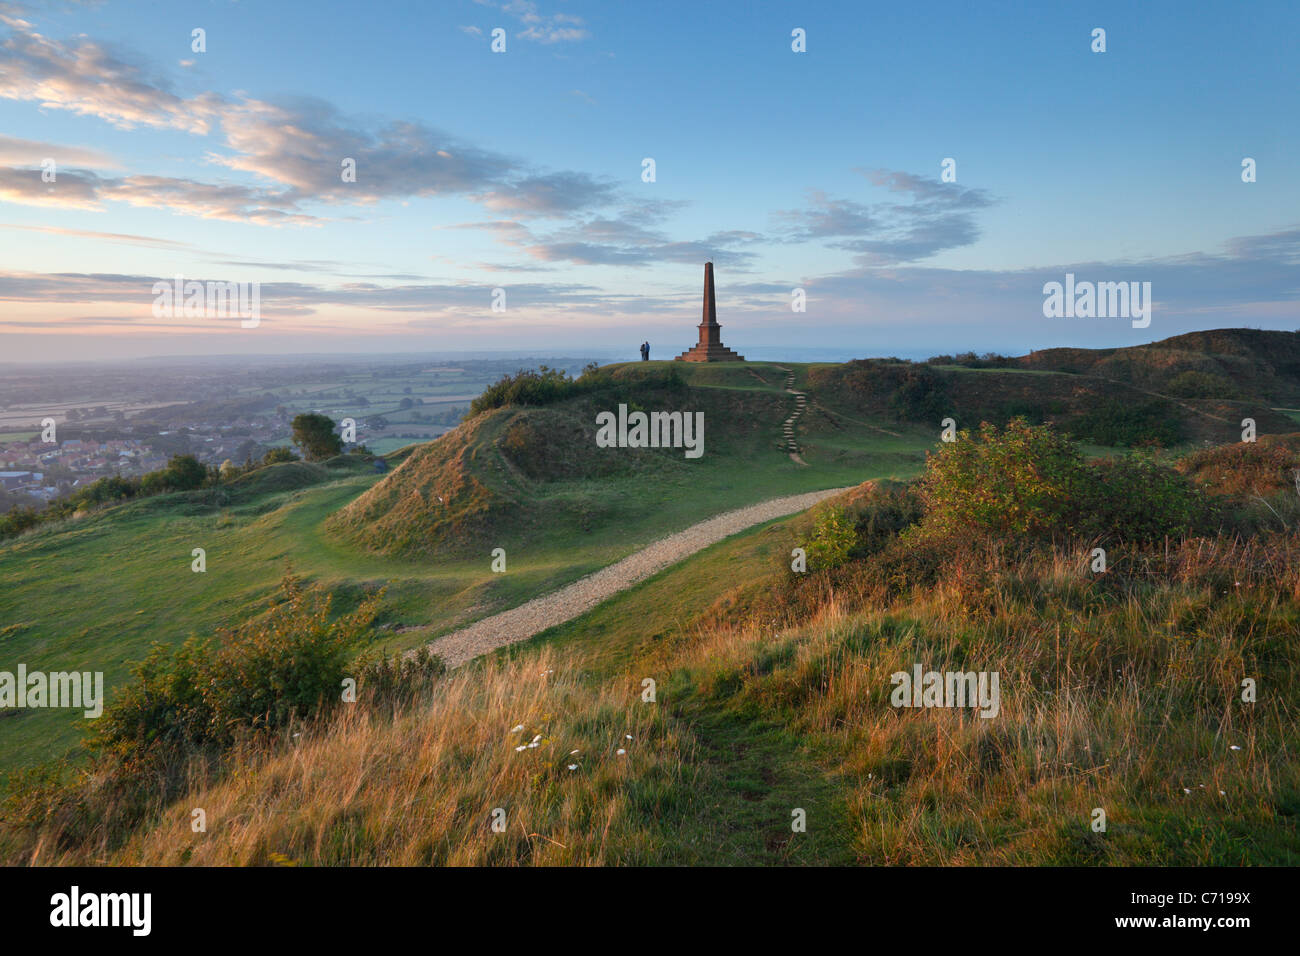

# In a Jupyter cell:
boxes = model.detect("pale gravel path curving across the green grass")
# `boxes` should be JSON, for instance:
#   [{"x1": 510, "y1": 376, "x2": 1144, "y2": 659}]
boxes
[{"x1": 421, "y1": 488, "x2": 846, "y2": 667}]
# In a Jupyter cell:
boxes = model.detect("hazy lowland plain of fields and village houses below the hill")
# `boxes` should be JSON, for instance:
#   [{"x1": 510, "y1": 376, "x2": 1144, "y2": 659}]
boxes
[{"x1": 0, "y1": 356, "x2": 589, "y2": 514}]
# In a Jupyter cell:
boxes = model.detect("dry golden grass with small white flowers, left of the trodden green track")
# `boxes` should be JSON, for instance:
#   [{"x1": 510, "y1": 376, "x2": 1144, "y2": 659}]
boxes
[{"x1": 54, "y1": 652, "x2": 690, "y2": 866}]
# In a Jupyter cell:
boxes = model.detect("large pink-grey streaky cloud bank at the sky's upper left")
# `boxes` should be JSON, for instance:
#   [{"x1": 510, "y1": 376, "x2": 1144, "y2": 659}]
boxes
[{"x1": 0, "y1": 10, "x2": 614, "y2": 225}]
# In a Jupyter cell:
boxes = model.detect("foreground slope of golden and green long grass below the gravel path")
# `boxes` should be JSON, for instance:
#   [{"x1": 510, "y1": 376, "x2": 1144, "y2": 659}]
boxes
[{"x1": 78, "y1": 489, "x2": 1300, "y2": 865}]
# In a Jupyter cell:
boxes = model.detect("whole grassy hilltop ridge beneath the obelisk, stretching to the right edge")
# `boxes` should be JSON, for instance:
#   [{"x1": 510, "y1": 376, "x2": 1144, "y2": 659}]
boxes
[{"x1": 328, "y1": 329, "x2": 1300, "y2": 558}]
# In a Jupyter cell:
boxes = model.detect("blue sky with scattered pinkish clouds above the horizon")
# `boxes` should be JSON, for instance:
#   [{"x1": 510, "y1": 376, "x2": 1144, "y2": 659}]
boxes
[{"x1": 0, "y1": 0, "x2": 1300, "y2": 360}]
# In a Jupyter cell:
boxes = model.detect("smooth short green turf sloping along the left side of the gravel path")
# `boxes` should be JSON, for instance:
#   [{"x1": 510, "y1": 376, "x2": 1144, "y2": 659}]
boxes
[{"x1": 0, "y1": 363, "x2": 932, "y2": 770}]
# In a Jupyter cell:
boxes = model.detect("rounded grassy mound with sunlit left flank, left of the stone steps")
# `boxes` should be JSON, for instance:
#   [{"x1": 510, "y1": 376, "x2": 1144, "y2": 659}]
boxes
[{"x1": 328, "y1": 367, "x2": 789, "y2": 558}]
